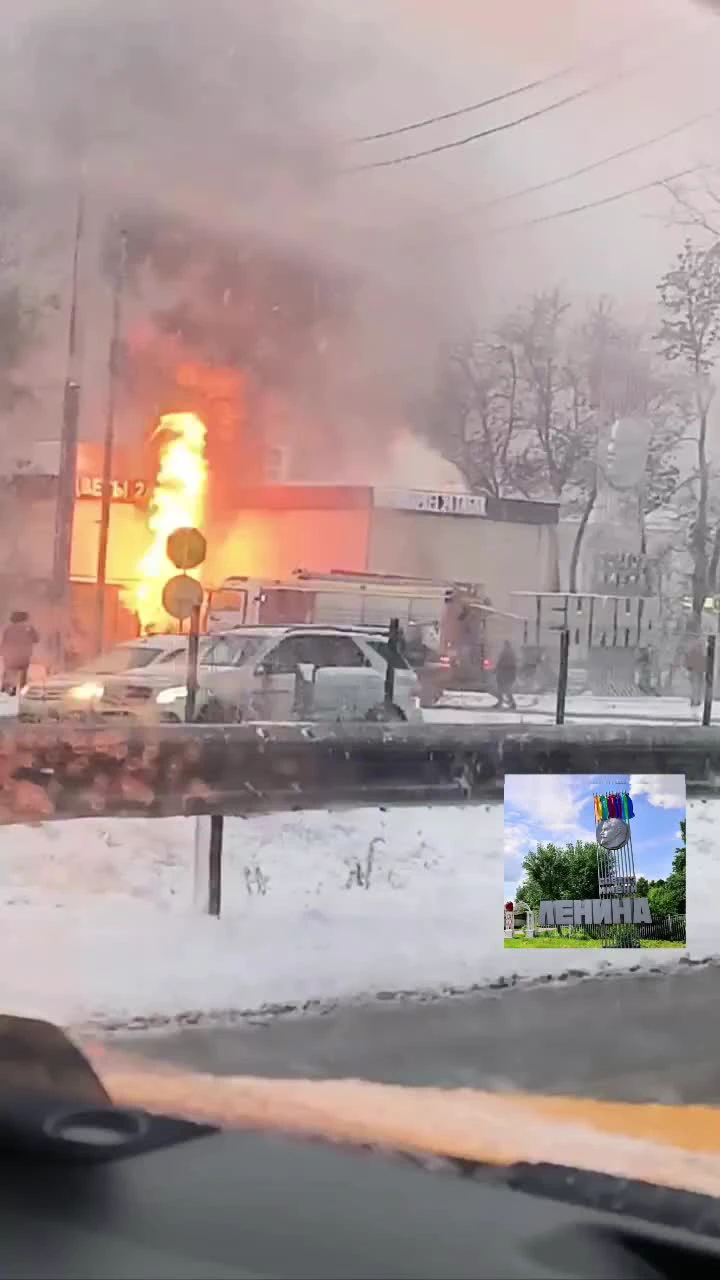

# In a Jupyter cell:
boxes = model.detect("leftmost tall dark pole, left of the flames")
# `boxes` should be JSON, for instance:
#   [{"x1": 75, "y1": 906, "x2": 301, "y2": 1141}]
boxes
[{"x1": 51, "y1": 187, "x2": 85, "y2": 666}]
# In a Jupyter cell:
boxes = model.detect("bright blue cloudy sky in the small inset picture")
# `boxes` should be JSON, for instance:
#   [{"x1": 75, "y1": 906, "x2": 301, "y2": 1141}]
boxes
[{"x1": 505, "y1": 773, "x2": 685, "y2": 900}]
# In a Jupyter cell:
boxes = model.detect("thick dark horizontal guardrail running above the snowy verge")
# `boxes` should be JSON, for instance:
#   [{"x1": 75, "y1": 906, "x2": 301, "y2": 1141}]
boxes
[{"x1": 0, "y1": 722, "x2": 720, "y2": 824}]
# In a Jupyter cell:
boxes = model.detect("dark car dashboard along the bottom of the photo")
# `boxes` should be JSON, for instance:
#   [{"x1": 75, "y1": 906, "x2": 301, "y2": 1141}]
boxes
[{"x1": 0, "y1": 1094, "x2": 720, "y2": 1280}]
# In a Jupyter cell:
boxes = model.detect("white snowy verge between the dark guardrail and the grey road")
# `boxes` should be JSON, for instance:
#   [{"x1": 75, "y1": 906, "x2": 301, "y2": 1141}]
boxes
[{"x1": 0, "y1": 800, "x2": 720, "y2": 1024}]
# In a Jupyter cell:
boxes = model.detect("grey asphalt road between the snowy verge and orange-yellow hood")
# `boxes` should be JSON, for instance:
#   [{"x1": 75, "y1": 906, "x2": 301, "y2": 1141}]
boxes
[{"x1": 114, "y1": 965, "x2": 720, "y2": 1105}]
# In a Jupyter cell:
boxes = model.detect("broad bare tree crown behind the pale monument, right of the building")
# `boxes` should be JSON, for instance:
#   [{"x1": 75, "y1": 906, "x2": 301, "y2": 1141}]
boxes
[{"x1": 429, "y1": 291, "x2": 687, "y2": 591}]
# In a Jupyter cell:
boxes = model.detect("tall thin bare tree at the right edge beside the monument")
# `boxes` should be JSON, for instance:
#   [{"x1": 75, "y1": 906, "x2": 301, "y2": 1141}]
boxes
[{"x1": 657, "y1": 239, "x2": 720, "y2": 625}]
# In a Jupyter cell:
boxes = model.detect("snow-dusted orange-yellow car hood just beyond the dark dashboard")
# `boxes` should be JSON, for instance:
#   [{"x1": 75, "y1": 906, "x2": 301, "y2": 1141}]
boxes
[{"x1": 85, "y1": 1046, "x2": 720, "y2": 1197}]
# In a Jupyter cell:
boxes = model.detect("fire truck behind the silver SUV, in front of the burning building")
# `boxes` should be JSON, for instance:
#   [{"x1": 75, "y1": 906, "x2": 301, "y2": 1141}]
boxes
[{"x1": 206, "y1": 570, "x2": 524, "y2": 705}]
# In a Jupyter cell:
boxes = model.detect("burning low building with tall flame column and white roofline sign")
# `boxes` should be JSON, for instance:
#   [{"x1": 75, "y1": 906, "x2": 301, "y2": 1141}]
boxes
[{"x1": 73, "y1": 435, "x2": 557, "y2": 645}]
